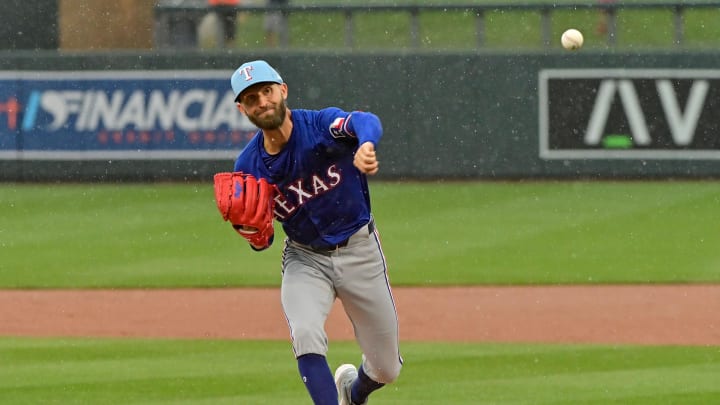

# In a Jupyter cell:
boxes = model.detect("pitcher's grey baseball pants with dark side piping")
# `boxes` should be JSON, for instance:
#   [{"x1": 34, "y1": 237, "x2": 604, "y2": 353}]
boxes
[{"x1": 281, "y1": 224, "x2": 402, "y2": 384}]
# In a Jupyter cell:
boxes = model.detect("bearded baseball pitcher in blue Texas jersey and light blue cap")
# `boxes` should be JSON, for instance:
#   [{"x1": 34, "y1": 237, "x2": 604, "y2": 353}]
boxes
[{"x1": 215, "y1": 60, "x2": 402, "y2": 405}]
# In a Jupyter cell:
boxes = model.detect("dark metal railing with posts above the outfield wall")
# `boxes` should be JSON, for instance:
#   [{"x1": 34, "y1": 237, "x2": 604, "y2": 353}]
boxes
[{"x1": 154, "y1": 0, "x2": 720, "y2": 49}]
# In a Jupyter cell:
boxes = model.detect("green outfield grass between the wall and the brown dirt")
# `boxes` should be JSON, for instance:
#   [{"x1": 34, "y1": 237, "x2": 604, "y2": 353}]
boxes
[{"x1": 0, "y1": 182, "x2": 720, "y2": 288}]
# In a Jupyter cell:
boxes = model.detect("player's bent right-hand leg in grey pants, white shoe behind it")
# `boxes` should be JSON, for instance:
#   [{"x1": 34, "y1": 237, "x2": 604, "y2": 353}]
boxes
[{"x1": 335, "y1": 224, "x2": 402, "y2": 403}]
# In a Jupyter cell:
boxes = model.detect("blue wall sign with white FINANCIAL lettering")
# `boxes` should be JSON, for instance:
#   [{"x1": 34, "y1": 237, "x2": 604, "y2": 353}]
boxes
[{"x1": 0, "y1": 70, "x2": 256, "y2": 160}]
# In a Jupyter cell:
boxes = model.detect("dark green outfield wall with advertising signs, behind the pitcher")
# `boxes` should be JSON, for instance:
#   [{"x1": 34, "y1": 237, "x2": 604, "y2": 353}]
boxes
[{"x1": 0, "y1": 51, "x2": 720, "y2": 181}]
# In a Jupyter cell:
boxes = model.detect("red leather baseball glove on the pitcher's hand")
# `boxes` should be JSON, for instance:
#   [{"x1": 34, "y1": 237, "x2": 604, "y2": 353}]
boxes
[{"x1": 214, "y1": 172, "x2": 277, "y2": 250}]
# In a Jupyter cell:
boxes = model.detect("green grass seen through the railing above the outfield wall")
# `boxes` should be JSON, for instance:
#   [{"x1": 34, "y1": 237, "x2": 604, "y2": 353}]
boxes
[{"x1": 221, "y1": 0, "x2": 720, "y2": 51}]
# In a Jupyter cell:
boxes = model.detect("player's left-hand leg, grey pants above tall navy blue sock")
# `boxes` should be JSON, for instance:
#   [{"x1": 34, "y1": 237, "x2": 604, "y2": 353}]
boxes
[{"x1": 281, "y1": 246, "x2": 337, "y2": 404}]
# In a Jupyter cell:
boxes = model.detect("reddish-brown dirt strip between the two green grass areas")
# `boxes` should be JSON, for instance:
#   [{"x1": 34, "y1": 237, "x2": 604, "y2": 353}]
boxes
[{"x1": 0, "y1": 285, "x2": 720, "y2": 345}]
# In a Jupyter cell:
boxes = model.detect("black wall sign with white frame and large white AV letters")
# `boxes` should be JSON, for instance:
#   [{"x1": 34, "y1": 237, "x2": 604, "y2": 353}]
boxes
[{"x1": 538, "y1": 69, "x2": 720, "y2": 159}]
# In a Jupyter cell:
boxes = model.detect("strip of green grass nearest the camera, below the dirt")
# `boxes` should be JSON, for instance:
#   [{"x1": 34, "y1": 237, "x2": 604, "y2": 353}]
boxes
[{"x1": 0, "y1": 338, "x2": 720, "y2": 405}]
